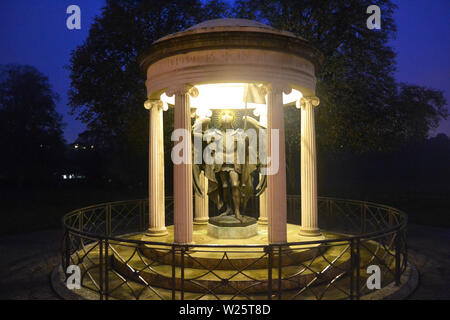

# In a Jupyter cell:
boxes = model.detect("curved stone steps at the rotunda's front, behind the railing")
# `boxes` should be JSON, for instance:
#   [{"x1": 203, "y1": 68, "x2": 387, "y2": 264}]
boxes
[{"x1": 111, "y1": 246, "x2": 350, "y2": 294}]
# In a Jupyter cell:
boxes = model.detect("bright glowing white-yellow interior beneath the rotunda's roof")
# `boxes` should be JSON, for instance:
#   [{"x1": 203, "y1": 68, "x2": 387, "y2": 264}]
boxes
[{"x1": 161, "y1": 83, "x2": 302, "y2": 117}]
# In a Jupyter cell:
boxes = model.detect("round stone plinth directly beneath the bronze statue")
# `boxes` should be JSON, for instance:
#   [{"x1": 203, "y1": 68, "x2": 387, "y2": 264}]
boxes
[{"x1": 208, "y1": 216, "x2": 258, "y2": 239}]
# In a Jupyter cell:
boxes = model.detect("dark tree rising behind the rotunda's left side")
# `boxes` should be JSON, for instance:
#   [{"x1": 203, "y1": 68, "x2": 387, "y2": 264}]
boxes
[{"x1": 69, "y1": 0, "x2": 232, "y2": 183}]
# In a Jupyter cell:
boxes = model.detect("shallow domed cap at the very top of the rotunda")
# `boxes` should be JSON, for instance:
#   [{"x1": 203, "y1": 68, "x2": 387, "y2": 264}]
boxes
[{"x1": 155, "y1": 18, "x2": 304, "y2": 43}]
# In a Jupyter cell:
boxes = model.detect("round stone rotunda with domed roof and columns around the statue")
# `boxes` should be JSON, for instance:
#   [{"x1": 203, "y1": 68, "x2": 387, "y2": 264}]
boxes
[{"x1": 141, "y1": 19, "x2": 322, "y2": 244}]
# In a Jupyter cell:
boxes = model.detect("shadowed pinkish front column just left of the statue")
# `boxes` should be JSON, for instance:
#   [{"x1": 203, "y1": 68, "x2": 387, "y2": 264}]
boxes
[{"x1": 166, "y1": 85, "x2": 198, "y2": 244}]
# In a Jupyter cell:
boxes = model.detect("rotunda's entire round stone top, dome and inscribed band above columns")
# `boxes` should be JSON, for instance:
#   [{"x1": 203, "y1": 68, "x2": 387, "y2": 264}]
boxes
[{"x1": 139, "y1": 19, "x2": 323, "y2": 98}]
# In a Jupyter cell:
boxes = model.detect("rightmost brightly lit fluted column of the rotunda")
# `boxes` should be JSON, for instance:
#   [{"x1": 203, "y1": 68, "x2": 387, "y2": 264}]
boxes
[{"x1": 300, "y1": 97, "x2": 320, "y2": 236}]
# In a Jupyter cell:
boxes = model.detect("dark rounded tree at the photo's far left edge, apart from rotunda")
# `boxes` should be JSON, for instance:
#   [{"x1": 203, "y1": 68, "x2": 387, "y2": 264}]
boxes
[{"x1": 0, "y1": 65, "x2": 64, "y2": 185}]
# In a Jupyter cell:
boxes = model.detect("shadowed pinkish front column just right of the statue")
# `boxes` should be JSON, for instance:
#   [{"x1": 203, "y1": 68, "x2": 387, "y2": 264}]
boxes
[{"x1": 266, "y1": 84, "x2": 290, "y2": 243}]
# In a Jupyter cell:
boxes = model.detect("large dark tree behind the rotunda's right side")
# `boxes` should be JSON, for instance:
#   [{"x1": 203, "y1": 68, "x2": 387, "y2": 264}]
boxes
[{"x1": 235, "y1": 0, "x2": 447, "y2": 152}]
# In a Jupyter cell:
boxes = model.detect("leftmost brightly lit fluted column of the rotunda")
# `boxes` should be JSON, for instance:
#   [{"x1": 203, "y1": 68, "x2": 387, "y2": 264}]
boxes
[{"x1": 144, "y1": 100, "x2": 167, "y2": 236}]
